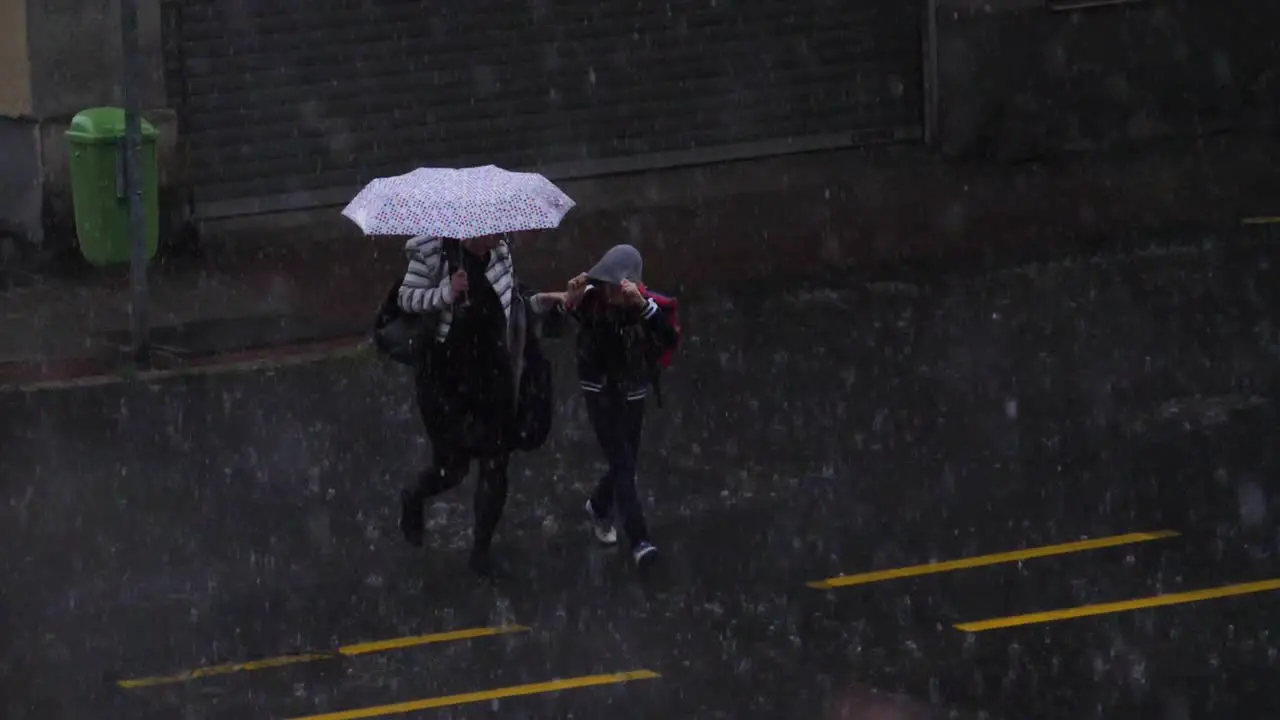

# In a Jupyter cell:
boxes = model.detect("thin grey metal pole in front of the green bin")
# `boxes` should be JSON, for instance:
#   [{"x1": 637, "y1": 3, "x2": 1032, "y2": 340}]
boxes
[{"x1": 120, "y1": 0, "x2": 151, "y2": 369}]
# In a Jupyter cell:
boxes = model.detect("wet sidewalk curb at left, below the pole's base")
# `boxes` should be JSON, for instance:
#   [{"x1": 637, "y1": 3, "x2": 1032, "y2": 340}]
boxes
[{"x1": 0, "y1": 336, "x2": 369, "y2": 393}]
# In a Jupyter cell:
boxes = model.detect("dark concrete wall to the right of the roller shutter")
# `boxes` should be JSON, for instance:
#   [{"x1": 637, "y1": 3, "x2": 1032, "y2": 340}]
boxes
[{"x1": 937, "y1": 0, "x2": 1280, "y2": 160}]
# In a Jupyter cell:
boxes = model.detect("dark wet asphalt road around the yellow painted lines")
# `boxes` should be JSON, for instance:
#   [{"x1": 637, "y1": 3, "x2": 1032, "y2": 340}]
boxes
[{"x1": 0, "y1": 238, "x2": 1280, "y2": 720}]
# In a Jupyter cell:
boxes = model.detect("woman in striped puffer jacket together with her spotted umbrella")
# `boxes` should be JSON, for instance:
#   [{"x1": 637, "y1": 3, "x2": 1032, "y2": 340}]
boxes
[{"x1": 343, "y1": 165, "x2": 573, "y2": 575}]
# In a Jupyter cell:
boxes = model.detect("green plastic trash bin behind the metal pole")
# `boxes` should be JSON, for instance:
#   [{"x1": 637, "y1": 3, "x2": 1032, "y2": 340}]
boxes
[{"x1": 67, "y1": 108, "x2": 160, "y2": 266}]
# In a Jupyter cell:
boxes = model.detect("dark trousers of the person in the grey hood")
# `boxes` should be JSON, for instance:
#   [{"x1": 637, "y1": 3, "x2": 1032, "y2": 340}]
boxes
[{"x1": 584, "y1": 391, "x2": 649, "y2": 547}]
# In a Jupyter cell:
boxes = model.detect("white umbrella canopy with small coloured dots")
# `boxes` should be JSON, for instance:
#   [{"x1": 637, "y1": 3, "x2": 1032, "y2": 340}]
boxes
[{"x1": 342, "y1": 165, "x2": 575, "y2": 240}]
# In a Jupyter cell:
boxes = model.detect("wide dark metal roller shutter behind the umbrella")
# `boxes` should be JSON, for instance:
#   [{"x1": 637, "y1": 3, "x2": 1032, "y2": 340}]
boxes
[{"x1": 166, "y1": 0, "x2": 922, "y2": 217}]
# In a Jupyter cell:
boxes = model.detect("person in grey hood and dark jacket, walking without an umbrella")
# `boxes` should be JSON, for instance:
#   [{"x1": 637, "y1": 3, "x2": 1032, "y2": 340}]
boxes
[{"x1": 547, "y1": 245, "x2": 678, "y2": 568}]
